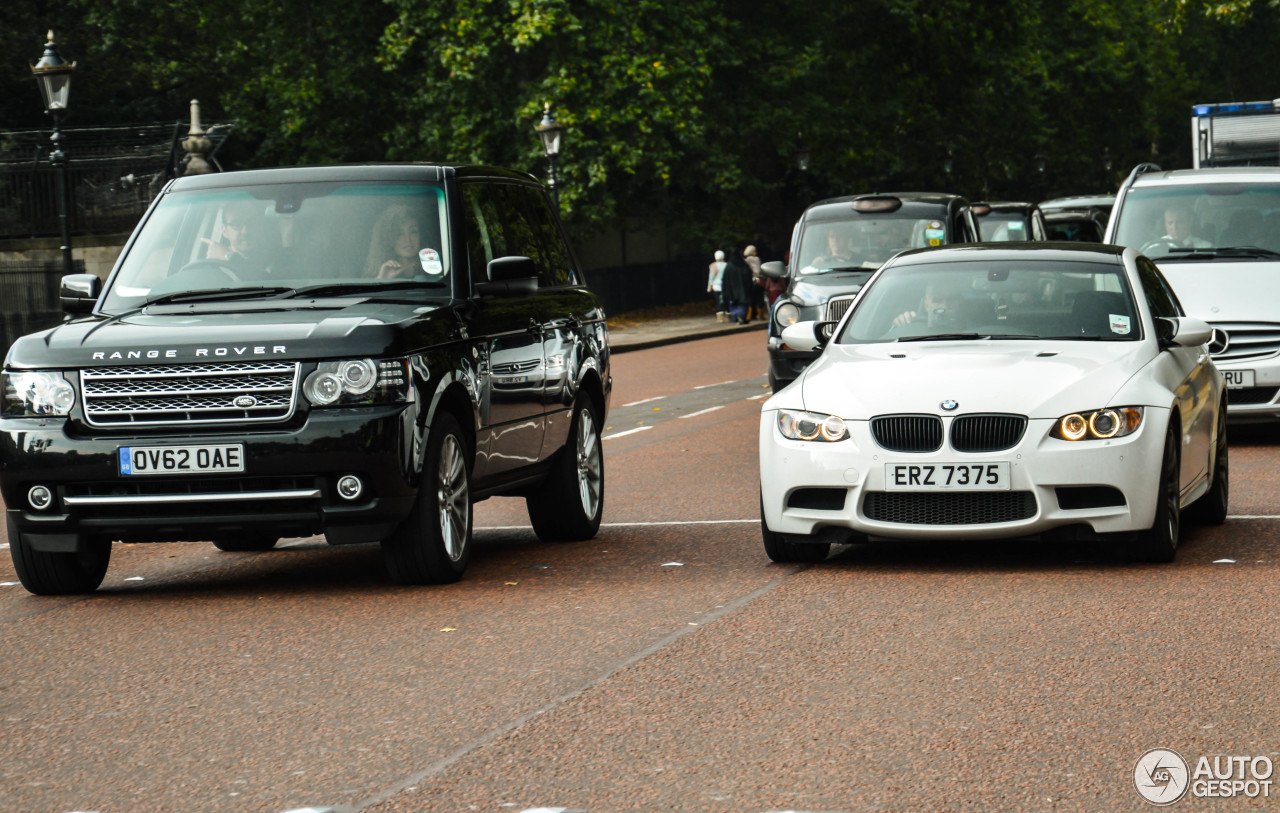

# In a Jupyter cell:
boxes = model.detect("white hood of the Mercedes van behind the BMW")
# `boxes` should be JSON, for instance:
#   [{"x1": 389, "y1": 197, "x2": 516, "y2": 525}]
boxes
[{"x1": 1156, "y1": 260, "x2": 1280, "y2": 324}]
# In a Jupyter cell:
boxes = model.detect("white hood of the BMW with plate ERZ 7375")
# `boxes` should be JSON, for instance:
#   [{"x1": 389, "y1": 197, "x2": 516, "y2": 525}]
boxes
[{"x1": 803, "y1": 342, "x2": 1151, "y2": 420}]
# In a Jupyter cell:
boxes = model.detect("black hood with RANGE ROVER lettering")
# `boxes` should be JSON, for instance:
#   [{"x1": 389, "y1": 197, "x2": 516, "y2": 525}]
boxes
[{"x1": 6, "y1": 300, "x2": 451, "y2": 369}]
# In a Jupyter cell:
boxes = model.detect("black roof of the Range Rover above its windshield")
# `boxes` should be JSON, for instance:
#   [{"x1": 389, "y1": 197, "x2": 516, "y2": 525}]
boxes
[{"x1": 170, "y1": 164, "x2": 538, "y2": 191}]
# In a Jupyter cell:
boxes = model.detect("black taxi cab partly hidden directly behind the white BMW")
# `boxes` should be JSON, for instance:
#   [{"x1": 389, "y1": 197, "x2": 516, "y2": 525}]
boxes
[{"x1": 760, "y1": 192, "x2": 979, "y2": 392}]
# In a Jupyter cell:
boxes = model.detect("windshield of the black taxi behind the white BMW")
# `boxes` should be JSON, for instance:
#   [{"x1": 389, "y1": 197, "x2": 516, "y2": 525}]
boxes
[{"x1": 795, "y1": 214, "x2": 950, "y2": 277}]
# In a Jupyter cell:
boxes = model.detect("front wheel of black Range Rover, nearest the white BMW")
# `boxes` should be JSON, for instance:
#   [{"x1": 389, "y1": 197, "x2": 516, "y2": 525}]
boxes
[{"x1": 381, "y1": 412, "x2": 472, "y2": 584}]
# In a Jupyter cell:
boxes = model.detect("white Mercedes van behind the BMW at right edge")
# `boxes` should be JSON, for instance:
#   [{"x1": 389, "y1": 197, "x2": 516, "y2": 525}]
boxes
[{"x1": 1105, "y1": 164, "x2": 1280, "y2": 423}]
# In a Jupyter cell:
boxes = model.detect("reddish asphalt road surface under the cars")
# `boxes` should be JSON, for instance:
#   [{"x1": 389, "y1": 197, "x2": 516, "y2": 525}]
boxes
[{"x1": 0, "y1": 333, "x2": 1280, "y2": 813}]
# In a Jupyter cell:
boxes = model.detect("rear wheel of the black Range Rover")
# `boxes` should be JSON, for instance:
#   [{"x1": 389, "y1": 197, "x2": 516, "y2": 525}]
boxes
[{"x1": 525, "y1": 394, "x2": 604, "y2": 542}]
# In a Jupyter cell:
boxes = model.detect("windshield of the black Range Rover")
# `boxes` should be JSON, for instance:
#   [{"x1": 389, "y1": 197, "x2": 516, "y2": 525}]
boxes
[{"x1": 104, "y1": 182, "x2": 452, "y2": 312}]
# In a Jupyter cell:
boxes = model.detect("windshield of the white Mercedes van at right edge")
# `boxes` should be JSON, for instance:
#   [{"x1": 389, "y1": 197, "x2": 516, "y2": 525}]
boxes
[{"x1": 1115, "y1": 183, "x2": 1280, "y2": 261}]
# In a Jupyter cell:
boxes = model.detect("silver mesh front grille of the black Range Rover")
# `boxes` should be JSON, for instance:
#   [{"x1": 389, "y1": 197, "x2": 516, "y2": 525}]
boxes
[{"x1": 81, "y1": 361, "x2": 300, "y2": 426}]
